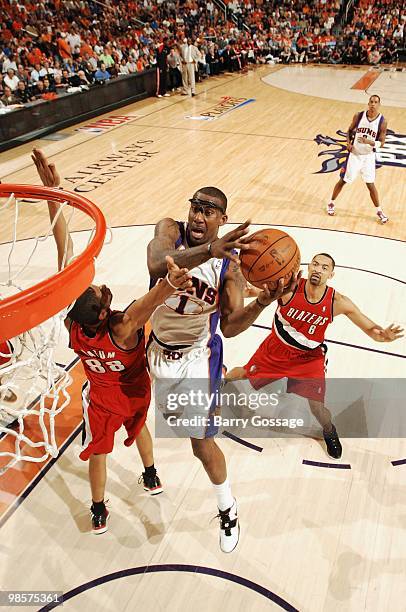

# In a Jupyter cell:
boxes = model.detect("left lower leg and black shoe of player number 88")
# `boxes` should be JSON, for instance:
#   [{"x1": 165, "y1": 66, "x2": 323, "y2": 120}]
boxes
[{"x1": 89, "y1": 453, "x2": 109, "y2": 534}]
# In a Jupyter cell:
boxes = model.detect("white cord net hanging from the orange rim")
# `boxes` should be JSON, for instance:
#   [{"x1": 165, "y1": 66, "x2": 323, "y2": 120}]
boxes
[{"x1": 0, "y1": 195, "x2": 75, "y2": 474}]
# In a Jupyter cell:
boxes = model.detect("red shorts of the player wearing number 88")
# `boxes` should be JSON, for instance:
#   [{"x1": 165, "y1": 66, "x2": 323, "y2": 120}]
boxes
[{"x1": 79, "y1": 377, "x2": 151, "y2": 461}]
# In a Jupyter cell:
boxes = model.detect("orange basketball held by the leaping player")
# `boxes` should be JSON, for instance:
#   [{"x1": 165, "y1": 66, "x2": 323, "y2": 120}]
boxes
[{"x1": 240, "y1": 229, "x2": 300, "y2": 289}]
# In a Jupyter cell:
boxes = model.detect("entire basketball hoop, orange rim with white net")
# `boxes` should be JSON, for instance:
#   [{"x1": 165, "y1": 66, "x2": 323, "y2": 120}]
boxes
[{"x1": 0, "y1": 184, "x2": 106, "y2": 475}]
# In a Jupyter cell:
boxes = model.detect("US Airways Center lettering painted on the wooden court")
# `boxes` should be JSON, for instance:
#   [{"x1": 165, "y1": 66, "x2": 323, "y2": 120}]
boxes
[{"x1": 64, "y1": 140, "x2": 159, "y2": 193}]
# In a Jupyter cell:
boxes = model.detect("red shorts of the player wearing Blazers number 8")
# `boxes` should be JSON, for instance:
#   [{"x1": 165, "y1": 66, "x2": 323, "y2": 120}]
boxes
[{"x1": 244, "y1": 336, "x2": 327, "y2": 403}]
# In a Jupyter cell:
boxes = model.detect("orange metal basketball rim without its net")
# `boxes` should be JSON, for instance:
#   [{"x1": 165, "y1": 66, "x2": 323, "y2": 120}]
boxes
[{"x1": 0, "y1": 183, "x2": 106, "y2": 342}]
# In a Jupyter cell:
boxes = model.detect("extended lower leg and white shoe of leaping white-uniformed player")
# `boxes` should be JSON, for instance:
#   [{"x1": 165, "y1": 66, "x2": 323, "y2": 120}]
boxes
[{"x1": 190, "y1": 438, "x2": 240, "y2": 553}]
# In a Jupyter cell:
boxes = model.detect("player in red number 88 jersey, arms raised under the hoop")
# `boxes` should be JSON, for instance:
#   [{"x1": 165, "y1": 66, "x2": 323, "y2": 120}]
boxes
[{"x1": 33, "y1": 149, "x2": 191, "y2": 534}]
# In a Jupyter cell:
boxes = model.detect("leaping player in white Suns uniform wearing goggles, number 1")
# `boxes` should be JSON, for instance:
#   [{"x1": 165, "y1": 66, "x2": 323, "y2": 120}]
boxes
[{"x1": 147, "y1": 187, "x2": 297, "y2": 552}]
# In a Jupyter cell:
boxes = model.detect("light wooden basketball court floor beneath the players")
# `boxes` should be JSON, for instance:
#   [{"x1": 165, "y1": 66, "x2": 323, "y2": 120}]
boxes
[{"x1": 0, "y1": 66, "x2": 406, "y2": 612}]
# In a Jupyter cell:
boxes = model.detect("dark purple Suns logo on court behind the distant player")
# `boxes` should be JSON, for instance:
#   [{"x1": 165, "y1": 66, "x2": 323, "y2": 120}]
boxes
[{"x1": 314, "y1": 130, "x2": 406, "y2": 174}]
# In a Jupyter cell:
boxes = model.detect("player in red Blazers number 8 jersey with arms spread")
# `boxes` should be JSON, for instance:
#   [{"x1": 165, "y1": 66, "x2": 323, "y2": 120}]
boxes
[{"x1": 225, "y1": 253, "x2": 403, "y2": 459}]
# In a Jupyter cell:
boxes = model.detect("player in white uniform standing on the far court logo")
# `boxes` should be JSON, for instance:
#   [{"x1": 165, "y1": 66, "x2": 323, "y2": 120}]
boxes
[{"x1": 327, "y1": 95, "x2": 389, "y2": 223}]
